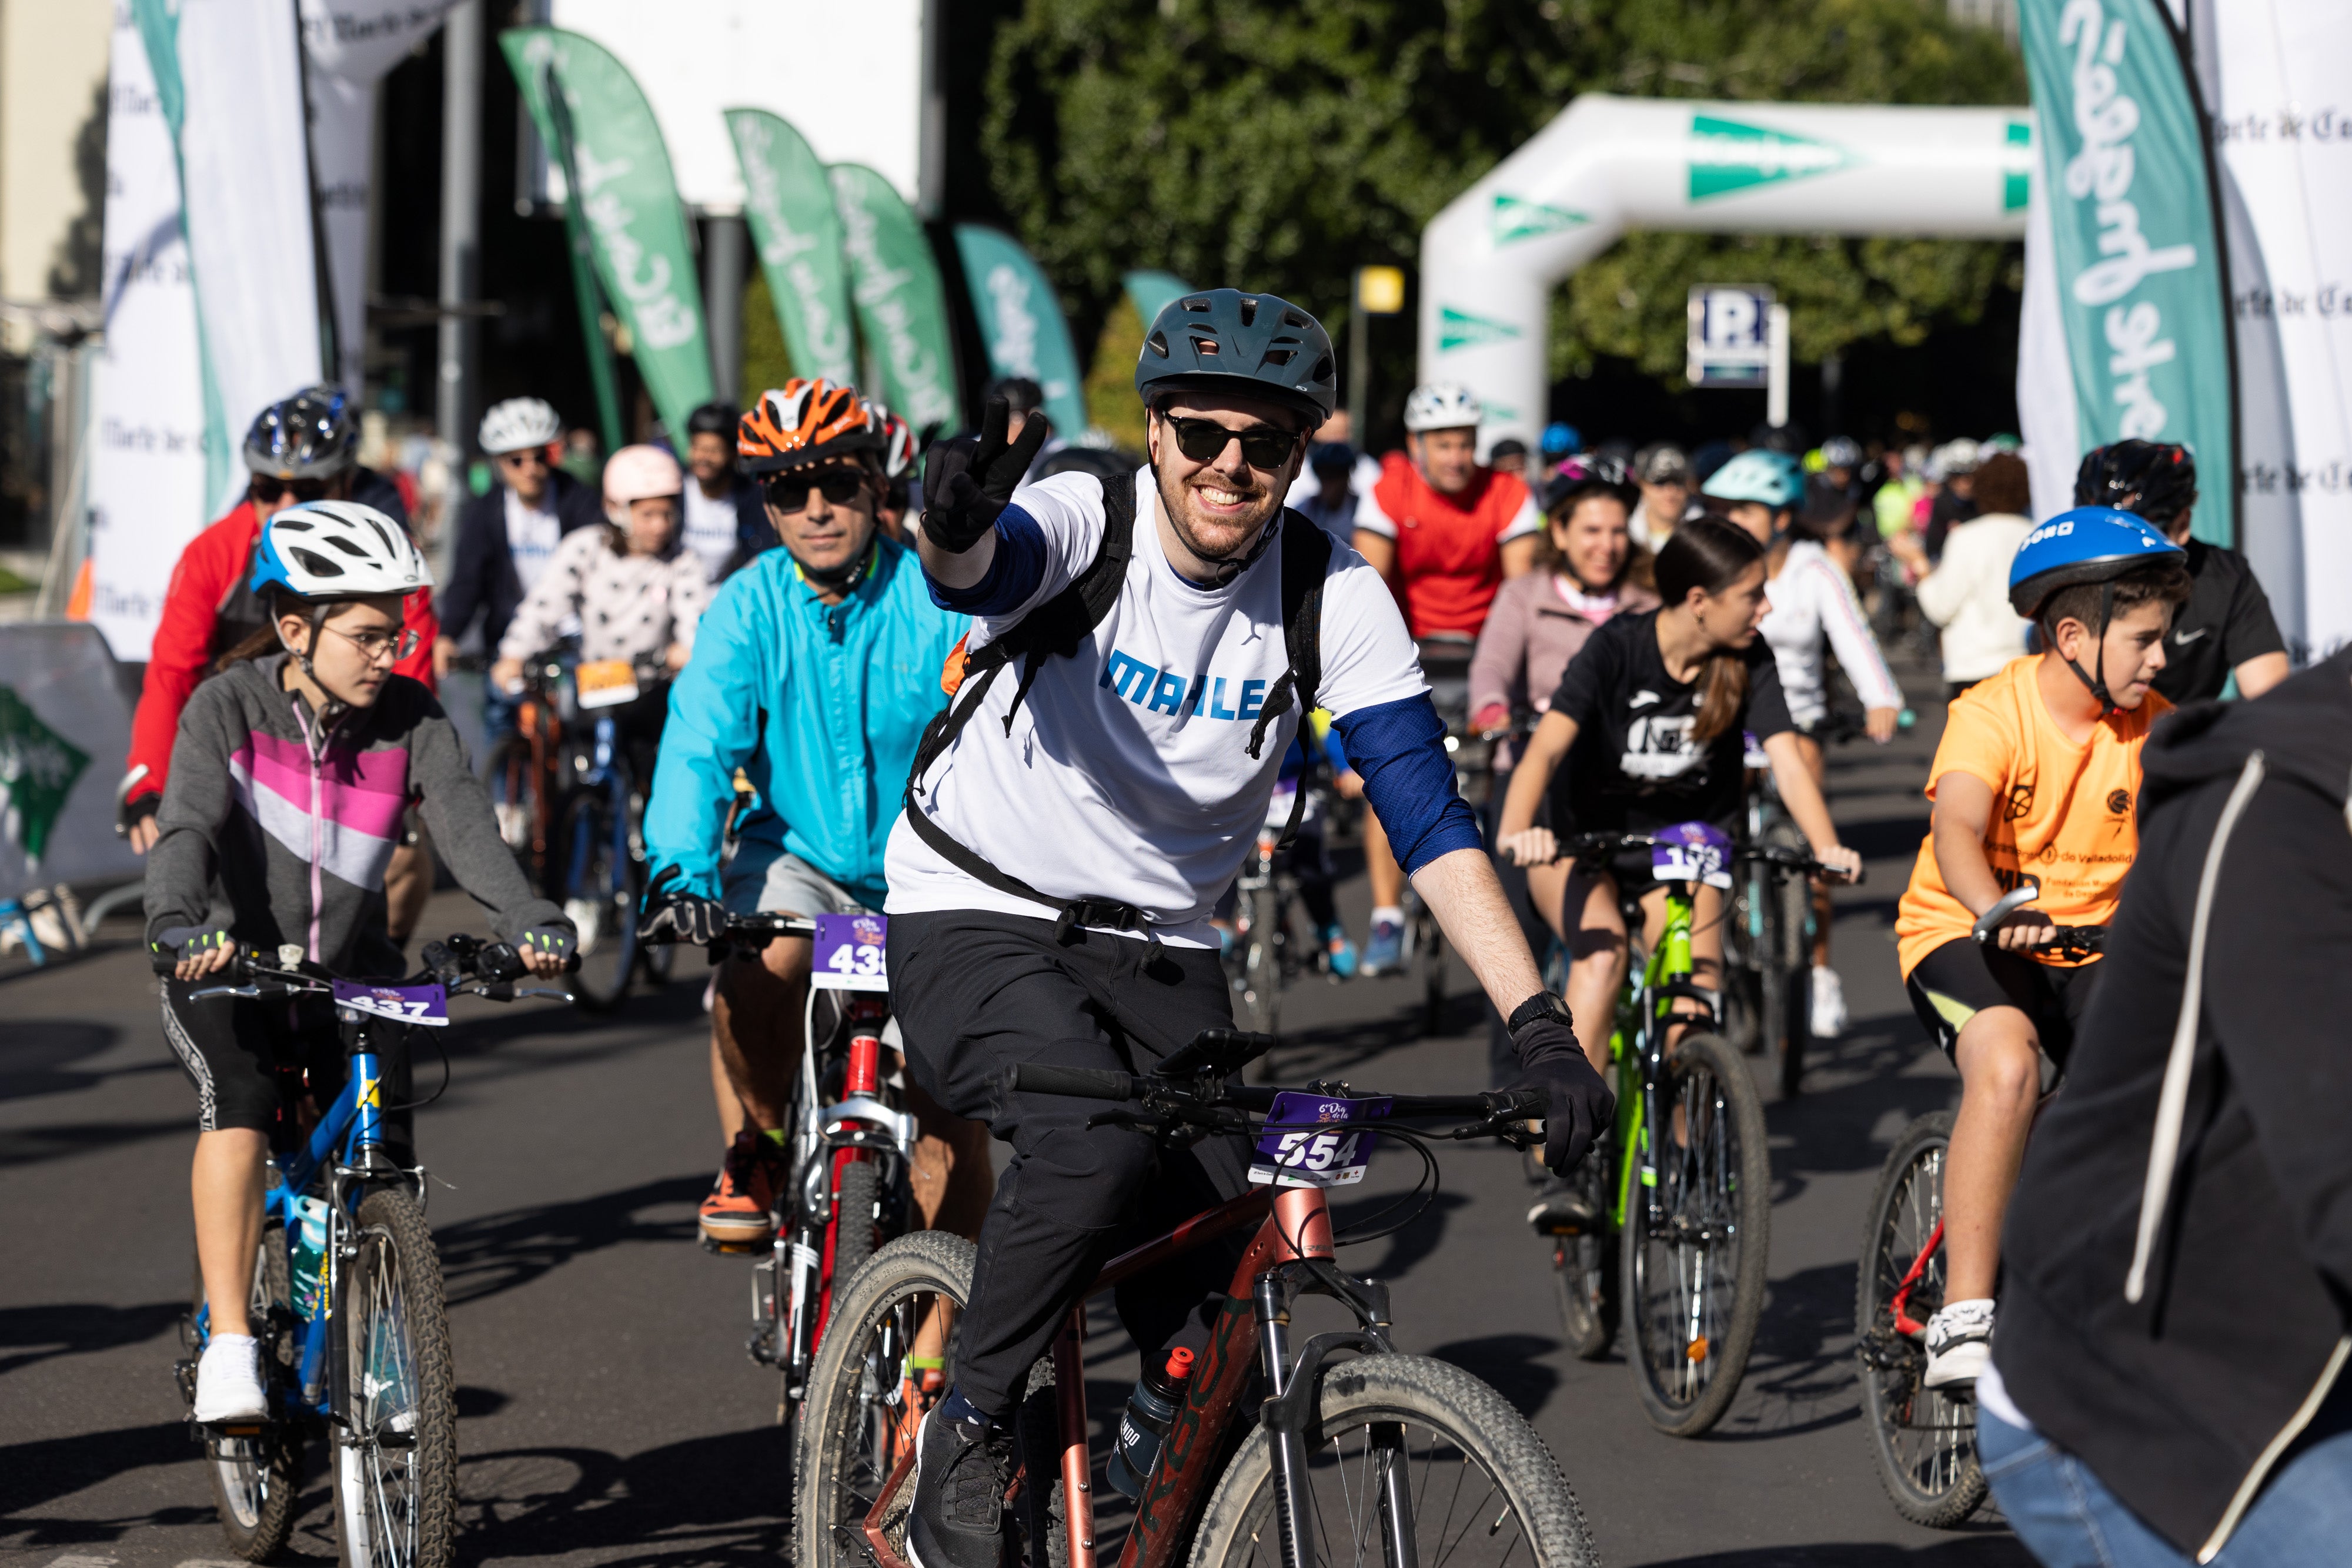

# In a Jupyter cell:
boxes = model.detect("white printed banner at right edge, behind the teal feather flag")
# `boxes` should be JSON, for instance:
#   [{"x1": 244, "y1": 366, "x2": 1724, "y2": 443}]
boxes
[{"x1": 2197, "y1": 0, "x2": 2352, "y2": 663}]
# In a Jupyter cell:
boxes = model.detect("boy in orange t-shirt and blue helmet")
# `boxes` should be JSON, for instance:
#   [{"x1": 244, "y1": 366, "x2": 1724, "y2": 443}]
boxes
[{"x1": 1896, "y1": 508, "x2": 2190, "y2": 1389}]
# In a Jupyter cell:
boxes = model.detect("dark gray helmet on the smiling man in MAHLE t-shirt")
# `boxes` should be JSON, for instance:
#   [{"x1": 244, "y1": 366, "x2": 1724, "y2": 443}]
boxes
[{"x1": 1136, "y1": 289, "x2": 1338, "y2": 423}]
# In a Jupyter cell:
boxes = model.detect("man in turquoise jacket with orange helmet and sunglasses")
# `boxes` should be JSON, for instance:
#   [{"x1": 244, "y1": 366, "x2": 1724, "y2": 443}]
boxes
[{"x1": 644, "y1": 381, "x2": 988, "y2": 1246}]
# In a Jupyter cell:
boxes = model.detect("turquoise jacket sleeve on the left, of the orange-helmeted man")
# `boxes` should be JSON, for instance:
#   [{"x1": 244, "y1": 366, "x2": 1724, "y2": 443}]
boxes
[{"x1": 644, "y1": 571, "x2": 783, "y2": 898}]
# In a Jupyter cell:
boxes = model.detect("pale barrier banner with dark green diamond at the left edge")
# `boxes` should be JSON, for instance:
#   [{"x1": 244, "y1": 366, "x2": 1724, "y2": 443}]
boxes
[{"x1": 0, "y1": 620, "x2": 139, "y2": 898}]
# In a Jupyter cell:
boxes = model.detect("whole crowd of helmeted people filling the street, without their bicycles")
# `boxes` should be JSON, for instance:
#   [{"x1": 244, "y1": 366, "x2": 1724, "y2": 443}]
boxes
[{"x1": 122, "y1": 289, "x2": 2352, "y2": 1568}]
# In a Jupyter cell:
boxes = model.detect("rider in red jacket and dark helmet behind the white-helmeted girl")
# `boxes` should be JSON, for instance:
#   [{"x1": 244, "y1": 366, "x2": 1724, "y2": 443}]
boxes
[{"x1": 115, "y1": 386, "x2": 440, "y2": 942}]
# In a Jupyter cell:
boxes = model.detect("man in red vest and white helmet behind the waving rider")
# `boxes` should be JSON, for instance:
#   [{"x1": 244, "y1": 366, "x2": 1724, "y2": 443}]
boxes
[{"x1": 1343, "y1": 381, "x2": 1543, "y2": 975}]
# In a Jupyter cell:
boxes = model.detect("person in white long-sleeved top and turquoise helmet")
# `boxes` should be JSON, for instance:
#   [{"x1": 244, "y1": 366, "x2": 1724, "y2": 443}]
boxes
[{"x1": 1700, "y1": 452, "x2": 1903, "y2": 1039}]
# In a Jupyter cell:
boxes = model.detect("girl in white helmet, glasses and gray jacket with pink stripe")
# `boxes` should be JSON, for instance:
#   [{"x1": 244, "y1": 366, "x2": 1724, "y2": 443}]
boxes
[{"x1": 146, "y1": 501, "x2": 574, "y2": 1422}]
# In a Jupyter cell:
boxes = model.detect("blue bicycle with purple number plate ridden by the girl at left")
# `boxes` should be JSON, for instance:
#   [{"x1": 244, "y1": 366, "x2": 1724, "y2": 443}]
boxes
[{"x1": 176, "y1": 935, "x2": 572, "y2": 1568}]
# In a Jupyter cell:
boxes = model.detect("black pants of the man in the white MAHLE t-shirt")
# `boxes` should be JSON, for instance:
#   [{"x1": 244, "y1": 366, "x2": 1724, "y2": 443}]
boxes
[{"x1": 889, "y1": 910, "x2": 1249, "y2": 1415}]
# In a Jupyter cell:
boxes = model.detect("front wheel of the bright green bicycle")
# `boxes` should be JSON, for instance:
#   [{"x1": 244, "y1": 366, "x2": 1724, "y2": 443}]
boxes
[{"x1": 1618, "y1": 1034, "x2": 1771, "y2": 1436}]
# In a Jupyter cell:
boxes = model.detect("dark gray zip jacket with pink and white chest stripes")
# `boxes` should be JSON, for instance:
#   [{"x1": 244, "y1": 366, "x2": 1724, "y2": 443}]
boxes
[{"x1": 146, "y1": 654, "x2": 572, "y2": 978}]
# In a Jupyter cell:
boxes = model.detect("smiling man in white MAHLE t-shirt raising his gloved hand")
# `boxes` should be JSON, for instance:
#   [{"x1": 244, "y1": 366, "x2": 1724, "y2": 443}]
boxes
[{"x1": 887, "y1": 289, "x2": 1613, "y2": 1568}]
